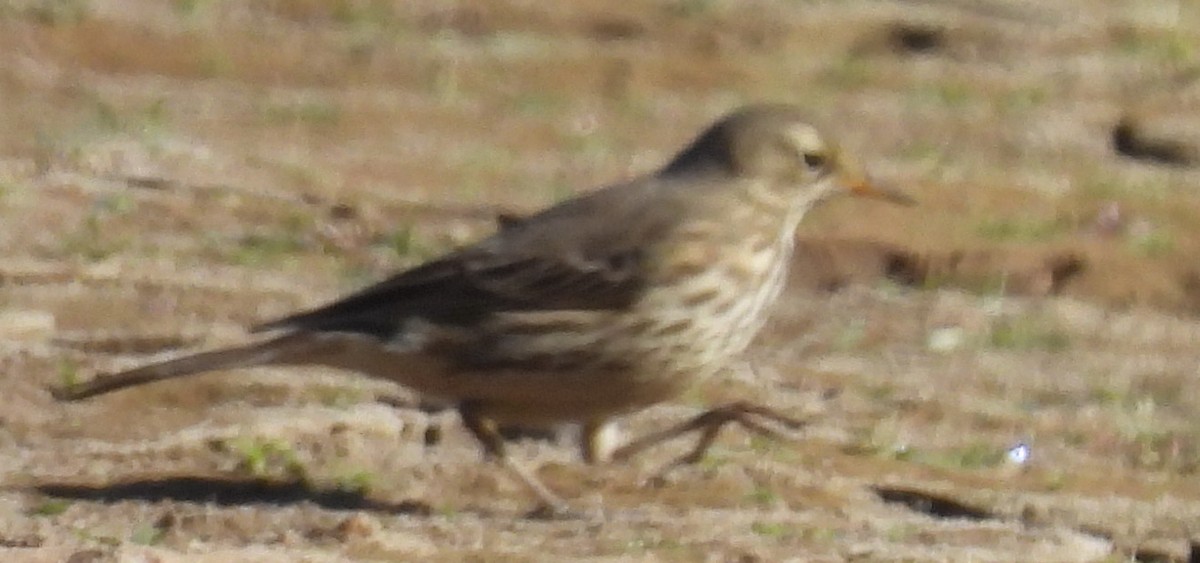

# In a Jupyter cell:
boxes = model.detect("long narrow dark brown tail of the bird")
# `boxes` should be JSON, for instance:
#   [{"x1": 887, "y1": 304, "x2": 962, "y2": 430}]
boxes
[{"x1": 50, "y1": 335, "x2": 307, "y2": 401}]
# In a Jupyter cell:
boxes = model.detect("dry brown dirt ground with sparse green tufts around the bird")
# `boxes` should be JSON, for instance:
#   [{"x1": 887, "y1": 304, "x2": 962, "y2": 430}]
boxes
[{"x1": 0, "y1": 0, "x2": 1200, "y2": 562}]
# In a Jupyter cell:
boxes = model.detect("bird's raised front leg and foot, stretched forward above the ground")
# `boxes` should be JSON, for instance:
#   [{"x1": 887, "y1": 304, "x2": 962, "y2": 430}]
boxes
[{"x1": 612, "y1": 402, "x2": 806, "y2": 473}]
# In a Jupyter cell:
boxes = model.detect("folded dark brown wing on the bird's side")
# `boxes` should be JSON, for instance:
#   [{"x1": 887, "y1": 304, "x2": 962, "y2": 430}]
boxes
[{"x1": 254, "y1": 178, "x2": 676, "y2": 337}]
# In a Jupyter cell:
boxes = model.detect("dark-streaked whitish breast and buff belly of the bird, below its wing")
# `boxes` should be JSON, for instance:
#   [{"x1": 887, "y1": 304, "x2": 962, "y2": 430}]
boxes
[{"x1": 408, "y1": 240, "x2": 786, "y2": 424}]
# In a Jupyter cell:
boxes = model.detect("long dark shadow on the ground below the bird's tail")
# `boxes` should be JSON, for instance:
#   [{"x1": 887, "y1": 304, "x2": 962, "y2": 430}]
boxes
[{"x1": 31, "y1": 477, "x2": 432, "y2": 515}]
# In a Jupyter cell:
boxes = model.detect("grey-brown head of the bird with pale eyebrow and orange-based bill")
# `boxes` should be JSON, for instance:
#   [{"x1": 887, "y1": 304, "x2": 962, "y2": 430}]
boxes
[{"x1": 662, "y1": 104, "x2": 913, "y2": 209}]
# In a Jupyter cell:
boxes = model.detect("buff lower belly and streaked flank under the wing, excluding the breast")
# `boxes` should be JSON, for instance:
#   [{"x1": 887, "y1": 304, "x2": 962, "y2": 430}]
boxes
[{"x1": 401, "y1": 311, "x2": 691, "y2": 424}]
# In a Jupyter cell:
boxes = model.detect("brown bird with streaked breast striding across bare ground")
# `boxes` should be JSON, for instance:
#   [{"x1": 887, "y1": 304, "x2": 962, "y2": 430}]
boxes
[{"x1": 52, "y1": 103, "x2": 913, "y2": 511}]
